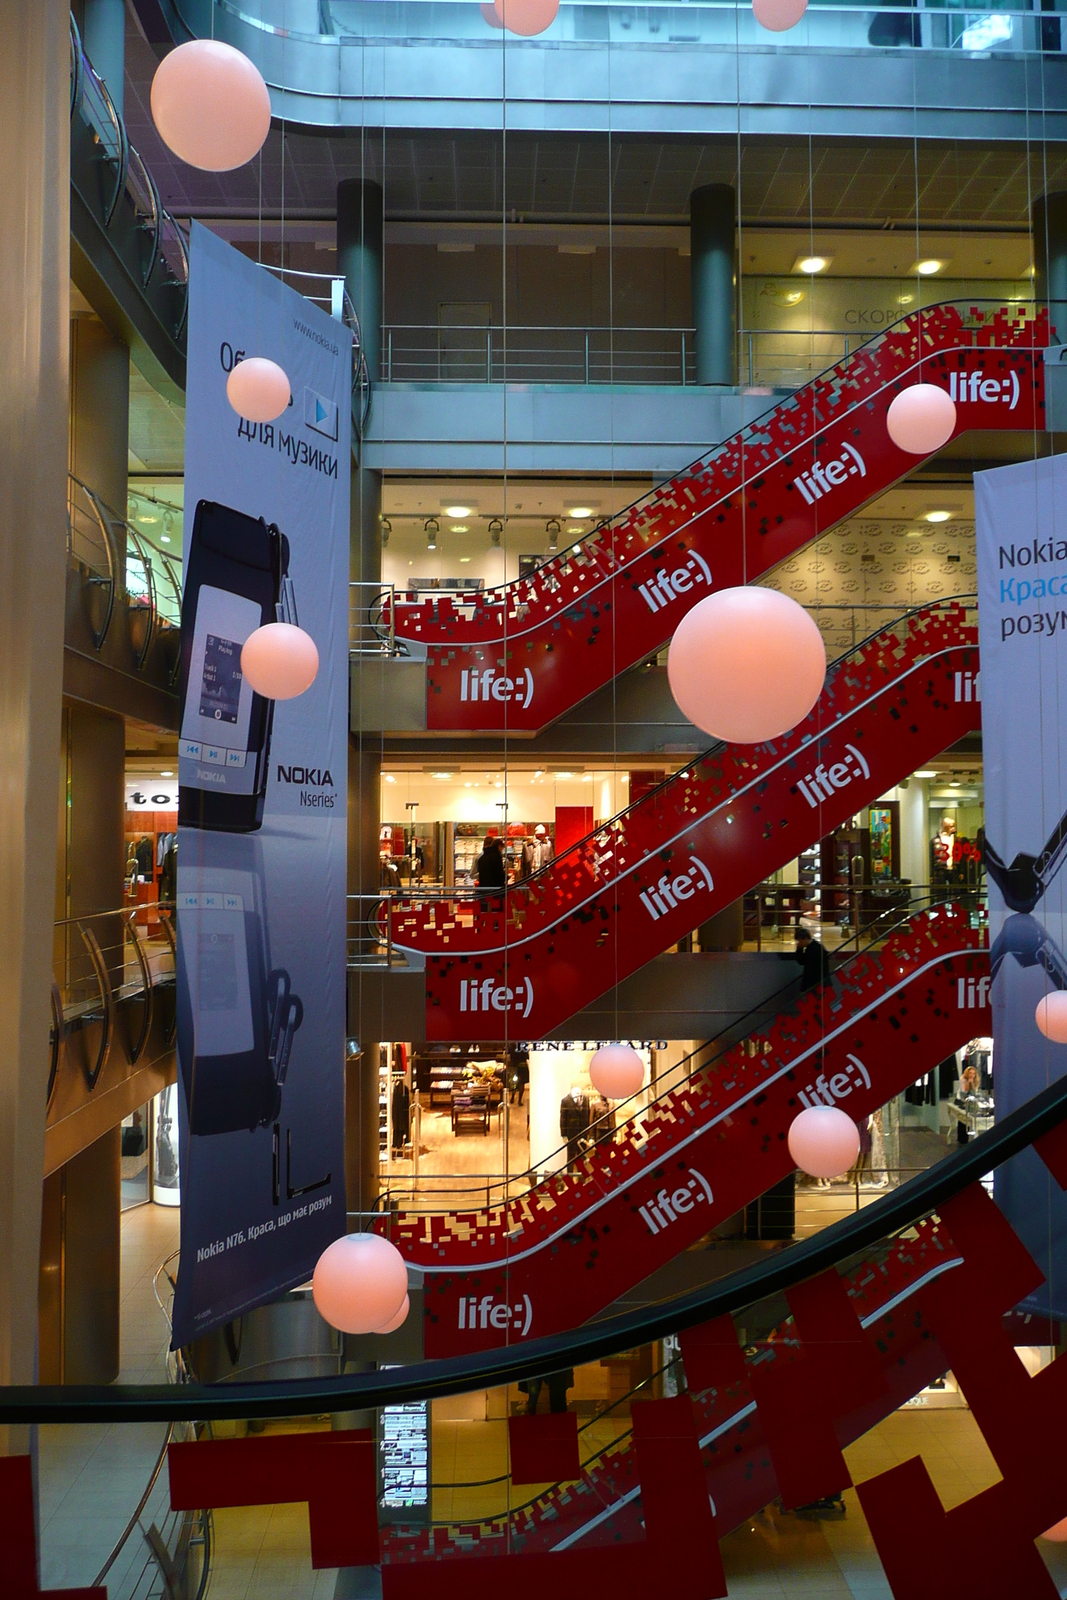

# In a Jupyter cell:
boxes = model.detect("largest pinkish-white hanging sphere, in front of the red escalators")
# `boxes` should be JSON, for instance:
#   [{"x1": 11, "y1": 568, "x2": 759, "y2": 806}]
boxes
[{"x1": 667, "y1": 587, "x2": 825, "y2": 744}]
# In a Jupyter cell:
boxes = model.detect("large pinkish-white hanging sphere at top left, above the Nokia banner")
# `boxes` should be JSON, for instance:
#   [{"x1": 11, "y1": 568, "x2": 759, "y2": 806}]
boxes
[{"x1": 152, "y1": 38, "x2": 270, "y2": 173}]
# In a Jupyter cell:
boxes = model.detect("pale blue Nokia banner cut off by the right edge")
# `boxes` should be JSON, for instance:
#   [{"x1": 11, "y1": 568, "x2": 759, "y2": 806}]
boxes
[{"x1": 974, "y1": 456, "x2": 1067, "y2": 1318}]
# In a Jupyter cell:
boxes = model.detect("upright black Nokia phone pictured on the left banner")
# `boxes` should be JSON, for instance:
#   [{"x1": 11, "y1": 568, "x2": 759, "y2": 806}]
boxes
[{"x1": 178, "y1": 501, "x2": 294, "y2": 834}]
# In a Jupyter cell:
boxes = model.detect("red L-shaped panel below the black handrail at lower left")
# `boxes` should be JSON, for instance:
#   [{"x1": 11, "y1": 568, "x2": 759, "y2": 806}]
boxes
[{"x1": 166, "y1": 1429, "x2": 379, "y2": 1568}]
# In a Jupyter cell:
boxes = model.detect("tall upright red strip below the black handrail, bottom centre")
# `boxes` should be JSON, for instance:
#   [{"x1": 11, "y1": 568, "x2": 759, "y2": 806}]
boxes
[{"x1": 630, "y1": 1395, "x2": 726, "y2": 1600}]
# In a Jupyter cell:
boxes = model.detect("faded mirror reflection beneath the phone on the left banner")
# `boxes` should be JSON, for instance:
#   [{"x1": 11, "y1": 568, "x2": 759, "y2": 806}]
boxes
[{"x1": 178, "y1": 837, "x2": 304, "y2": 1134}]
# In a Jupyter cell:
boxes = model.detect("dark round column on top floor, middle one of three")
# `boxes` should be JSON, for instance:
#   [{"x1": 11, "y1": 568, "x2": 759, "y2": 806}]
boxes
[{"x1": 689, "y1": 184, "x2": 737, "y2": 386}]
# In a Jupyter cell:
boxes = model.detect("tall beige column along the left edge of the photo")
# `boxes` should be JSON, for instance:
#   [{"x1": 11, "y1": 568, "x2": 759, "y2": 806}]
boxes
[{"x1": 0, "y1": 0, "x2": 70, "y2": 1453}]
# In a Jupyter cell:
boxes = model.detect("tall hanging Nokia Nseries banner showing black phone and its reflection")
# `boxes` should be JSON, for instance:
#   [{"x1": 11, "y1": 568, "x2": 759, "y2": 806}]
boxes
[{"x1": 173, "y1": 222, "x2": 352, "y2": 1347}]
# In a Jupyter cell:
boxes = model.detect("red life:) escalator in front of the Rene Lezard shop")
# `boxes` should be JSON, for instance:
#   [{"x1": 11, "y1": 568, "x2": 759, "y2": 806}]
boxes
[{"x1": 399, "y1": 904, "x2": 992, "y2": 1357}]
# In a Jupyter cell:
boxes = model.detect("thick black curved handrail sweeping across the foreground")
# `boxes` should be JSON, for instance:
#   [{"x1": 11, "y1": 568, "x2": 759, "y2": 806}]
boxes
[{"x1": 0, "y1": 1077, "x2": 1067, "y2": 1424}]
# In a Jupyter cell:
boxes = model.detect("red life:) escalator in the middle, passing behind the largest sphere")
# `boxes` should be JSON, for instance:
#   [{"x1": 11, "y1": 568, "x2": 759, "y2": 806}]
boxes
[{"x1": 382, "y1": 600, "x2": 981, "y2": 1040}]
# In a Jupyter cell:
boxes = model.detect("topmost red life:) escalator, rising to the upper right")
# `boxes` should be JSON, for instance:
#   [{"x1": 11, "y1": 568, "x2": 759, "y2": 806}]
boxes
[{"x1": 394, "y1": 302, "x2": 1048, "y2": 734}]
